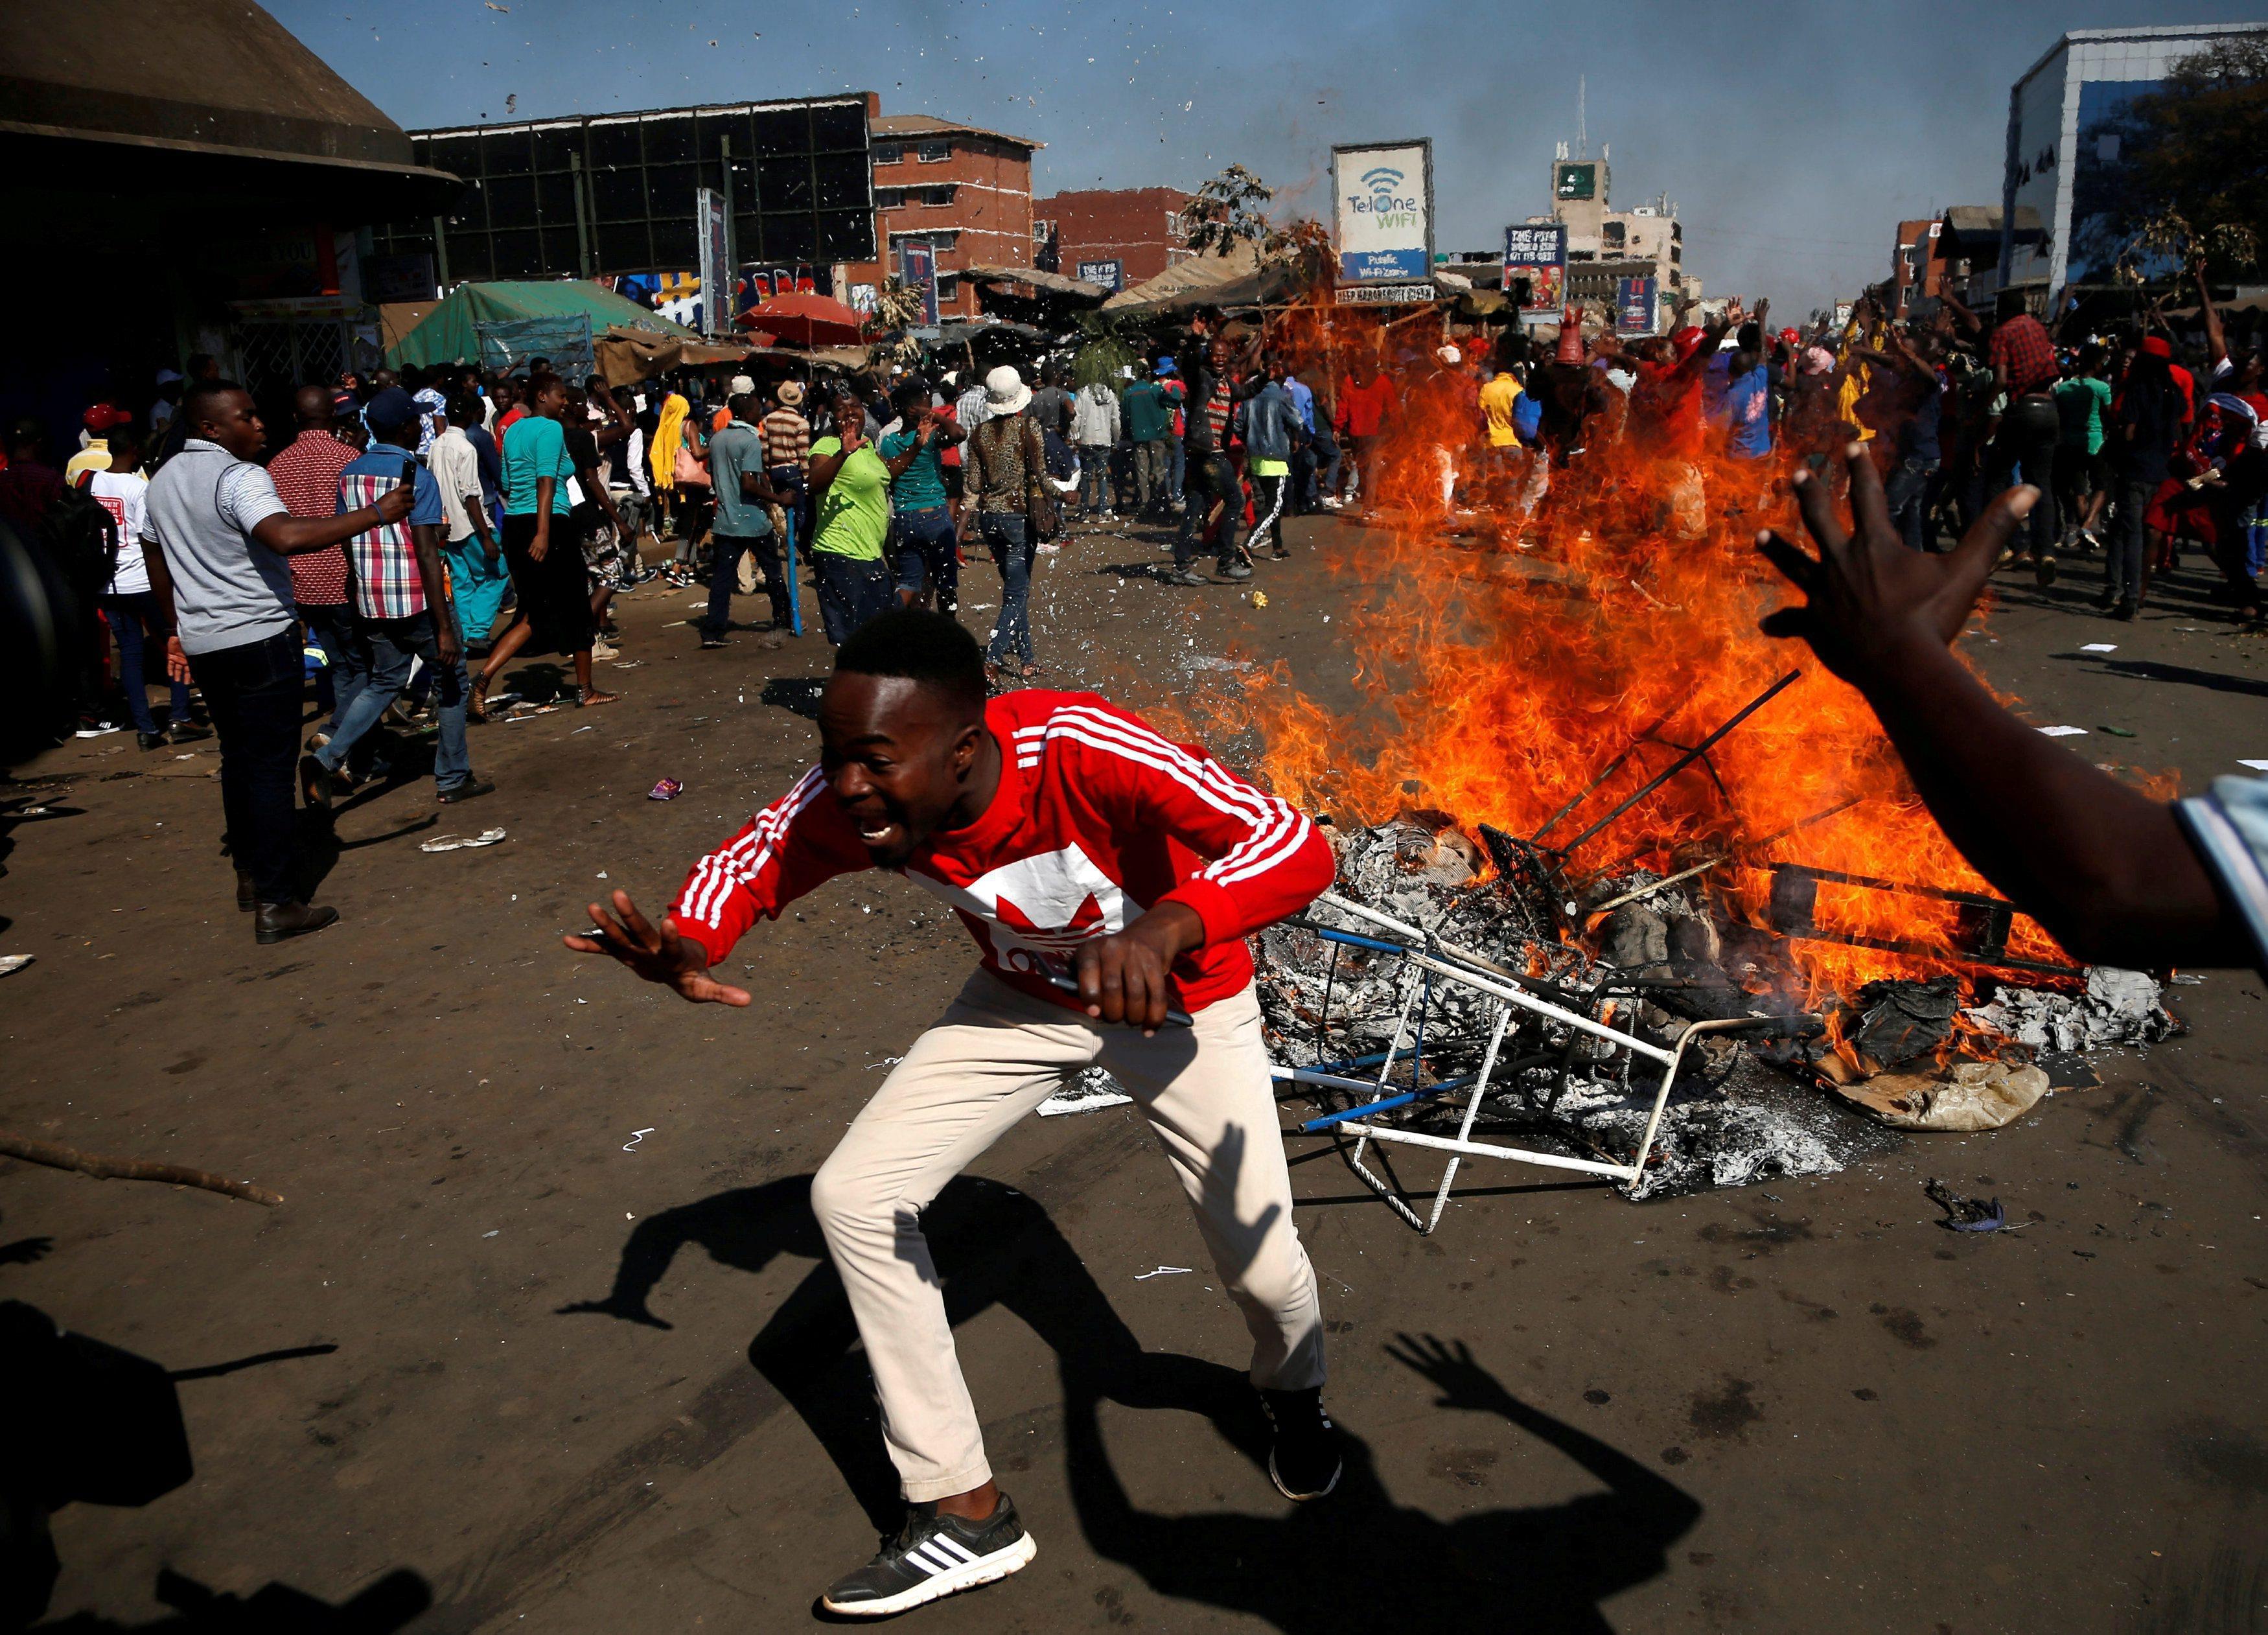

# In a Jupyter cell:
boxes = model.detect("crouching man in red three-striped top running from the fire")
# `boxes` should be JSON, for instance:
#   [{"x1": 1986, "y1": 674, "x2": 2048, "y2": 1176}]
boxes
[{"x1": 567, "y1": 610, "x2": 1341, "y2": 1617}]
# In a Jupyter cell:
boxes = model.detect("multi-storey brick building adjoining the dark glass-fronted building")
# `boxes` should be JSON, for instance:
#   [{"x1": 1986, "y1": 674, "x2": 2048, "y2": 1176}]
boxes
[{"x1": 846, "y1": 113, "x2": 1043, "y2": 318}]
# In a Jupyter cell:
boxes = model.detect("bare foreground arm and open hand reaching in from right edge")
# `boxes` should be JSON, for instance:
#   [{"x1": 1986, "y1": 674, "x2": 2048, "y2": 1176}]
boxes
[{"x1": 1758, "y1": 445, "x2": 2252, "y2": 968}]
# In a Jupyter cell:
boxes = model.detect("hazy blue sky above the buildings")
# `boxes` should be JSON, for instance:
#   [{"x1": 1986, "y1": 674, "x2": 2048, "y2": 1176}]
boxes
[{"x1": 270, "y1": 0, "x2": 2263, "y2": 318}]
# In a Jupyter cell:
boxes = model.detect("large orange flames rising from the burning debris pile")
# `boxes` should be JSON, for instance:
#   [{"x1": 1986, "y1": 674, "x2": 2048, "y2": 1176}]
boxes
[{"x1": 1188, "y1": 299, "x2": 2159, "y2": 1007}]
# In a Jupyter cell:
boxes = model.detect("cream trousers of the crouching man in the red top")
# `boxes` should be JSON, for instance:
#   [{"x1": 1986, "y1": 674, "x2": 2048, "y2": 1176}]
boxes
[{"x1": 812, "y1": 971, "x2": 1323, "y2": 1503}]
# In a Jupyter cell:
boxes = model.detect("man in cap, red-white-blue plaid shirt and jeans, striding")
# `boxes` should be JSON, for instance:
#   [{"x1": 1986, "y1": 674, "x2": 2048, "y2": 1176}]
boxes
[{"x1": 299, "y1": 386, "x2": 497, "y2": 807}]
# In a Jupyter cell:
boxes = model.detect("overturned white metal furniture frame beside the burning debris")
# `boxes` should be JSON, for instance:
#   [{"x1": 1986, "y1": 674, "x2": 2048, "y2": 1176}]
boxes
[{"x1": 1275, "y1": 891, "x2": 1751, "y2": 1234}]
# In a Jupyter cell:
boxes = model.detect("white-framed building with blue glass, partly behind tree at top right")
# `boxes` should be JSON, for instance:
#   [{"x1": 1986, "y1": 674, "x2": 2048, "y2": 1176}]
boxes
[{"x1": 2000, "y1": 23, "x2": 2268, "y2": 308}]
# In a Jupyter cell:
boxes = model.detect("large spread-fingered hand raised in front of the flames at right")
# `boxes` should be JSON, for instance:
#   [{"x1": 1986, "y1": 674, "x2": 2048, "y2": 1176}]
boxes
[{"x1": 1755, "y1": 442, "x2": 2039, "y2": 687}]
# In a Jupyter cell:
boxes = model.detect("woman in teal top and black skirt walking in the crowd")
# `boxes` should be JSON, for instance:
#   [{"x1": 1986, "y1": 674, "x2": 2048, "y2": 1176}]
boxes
[{"x1": 467, "y1": 374, "x2": 615, "y2": 721}]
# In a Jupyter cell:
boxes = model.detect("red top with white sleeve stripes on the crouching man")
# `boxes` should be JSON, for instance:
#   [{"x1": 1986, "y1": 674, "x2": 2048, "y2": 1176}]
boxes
[{"x1": 671, "y1": 687, "x2": 1334, "y2": 1012}]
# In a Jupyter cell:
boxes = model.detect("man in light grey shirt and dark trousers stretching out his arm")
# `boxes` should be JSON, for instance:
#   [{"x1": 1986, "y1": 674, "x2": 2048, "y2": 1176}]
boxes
[{"x1": 143, "y1": 378, "x2": 411, "y2": 944}]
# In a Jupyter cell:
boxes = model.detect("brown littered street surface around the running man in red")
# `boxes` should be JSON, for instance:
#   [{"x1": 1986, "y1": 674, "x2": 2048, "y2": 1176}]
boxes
[{"x1": 0, "y1": 503, "x2": 2268, "y2": 1635}]
